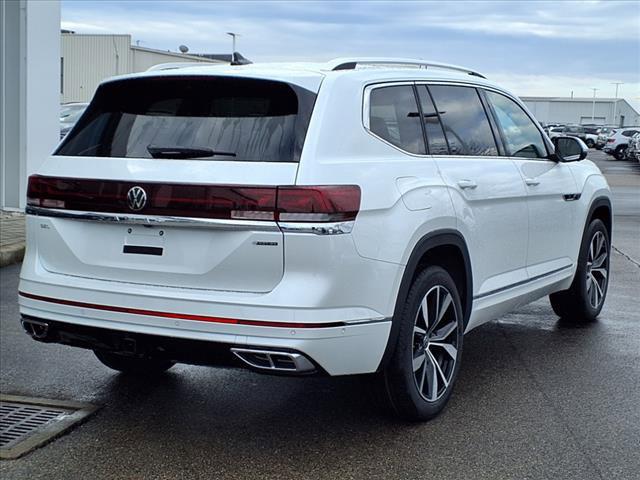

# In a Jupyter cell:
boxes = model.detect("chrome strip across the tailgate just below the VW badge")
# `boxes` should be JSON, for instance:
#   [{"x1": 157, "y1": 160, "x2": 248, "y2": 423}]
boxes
[{"x1": 25, "y1": 206, "x2": 280, "y2": 232}]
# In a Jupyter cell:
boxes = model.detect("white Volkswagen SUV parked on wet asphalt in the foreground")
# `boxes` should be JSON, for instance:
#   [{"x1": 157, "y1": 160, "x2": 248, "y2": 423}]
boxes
[{"x1": 20, "y1": 59, "x2": 612, "y2": 420}]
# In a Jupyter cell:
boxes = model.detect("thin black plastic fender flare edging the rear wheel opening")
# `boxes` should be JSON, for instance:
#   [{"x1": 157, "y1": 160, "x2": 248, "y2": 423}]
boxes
[{"x1": 378, "y1": 229, "x2": 473, "y2": 371}]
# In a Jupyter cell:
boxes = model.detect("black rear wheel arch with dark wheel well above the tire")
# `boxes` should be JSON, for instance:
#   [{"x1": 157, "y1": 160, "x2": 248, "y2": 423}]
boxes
[{"x1": 378, "y1": 229, "x2": 473, "y2": 370}]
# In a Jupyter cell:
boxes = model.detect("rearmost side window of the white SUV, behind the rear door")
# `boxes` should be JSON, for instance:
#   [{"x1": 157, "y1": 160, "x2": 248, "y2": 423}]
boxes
[{"x1": 369, "y1": 85, "x2": 426, "y2": 154}]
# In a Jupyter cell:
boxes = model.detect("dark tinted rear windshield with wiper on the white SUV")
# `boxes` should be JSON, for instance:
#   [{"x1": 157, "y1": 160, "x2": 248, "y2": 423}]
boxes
[{"x1": 55, "y1": 77, "x2": 316, "y2": 162}]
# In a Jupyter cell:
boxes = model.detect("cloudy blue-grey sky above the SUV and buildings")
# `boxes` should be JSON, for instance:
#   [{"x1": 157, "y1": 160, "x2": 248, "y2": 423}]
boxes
[{"x1": 62, "y1": 0, "x2": 640, "y2": 109}]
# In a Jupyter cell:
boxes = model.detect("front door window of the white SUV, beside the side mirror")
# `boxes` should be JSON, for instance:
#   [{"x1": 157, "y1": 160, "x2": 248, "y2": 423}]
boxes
[{"x1": 486, "y1": 91, "x2": 548, "y2": 158}]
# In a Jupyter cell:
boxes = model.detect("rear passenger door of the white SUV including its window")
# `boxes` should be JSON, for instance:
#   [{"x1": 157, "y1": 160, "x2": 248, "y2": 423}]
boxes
[{"x1": 418, "y1": 85, "x2": 528, "y2": 297}]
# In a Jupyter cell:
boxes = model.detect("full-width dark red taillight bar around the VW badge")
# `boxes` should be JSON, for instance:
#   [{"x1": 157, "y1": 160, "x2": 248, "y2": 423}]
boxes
[{"x1": 27, "y1": 175, "x2": 360, "y2": 222}]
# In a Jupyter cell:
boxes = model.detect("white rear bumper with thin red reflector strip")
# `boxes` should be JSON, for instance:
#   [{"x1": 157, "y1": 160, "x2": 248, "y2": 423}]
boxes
[{"x1": 19, "y1": 281, "x2": 391, "y2": 375}]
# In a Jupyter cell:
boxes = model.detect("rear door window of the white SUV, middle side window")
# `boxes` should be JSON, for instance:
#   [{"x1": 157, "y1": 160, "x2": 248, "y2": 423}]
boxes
[{"x1": 429, "y1": 85, "x2": 498, "y2": 155}]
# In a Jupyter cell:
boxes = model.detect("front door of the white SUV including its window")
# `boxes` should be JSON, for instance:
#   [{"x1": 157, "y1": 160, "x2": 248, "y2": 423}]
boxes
[{"x1": 485, "y1": 90, "x2": 580, "y2": 278}]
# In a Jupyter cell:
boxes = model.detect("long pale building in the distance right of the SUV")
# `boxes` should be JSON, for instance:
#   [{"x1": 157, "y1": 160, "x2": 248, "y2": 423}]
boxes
[{"x1": 520, "y1": 97, "x2": 640, "y2": 126}]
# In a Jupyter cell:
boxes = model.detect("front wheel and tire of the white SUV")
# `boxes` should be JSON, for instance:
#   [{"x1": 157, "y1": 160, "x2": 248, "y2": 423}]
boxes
[{"x1": 549, "y1": 219, "x2": 611, "y2": 323}]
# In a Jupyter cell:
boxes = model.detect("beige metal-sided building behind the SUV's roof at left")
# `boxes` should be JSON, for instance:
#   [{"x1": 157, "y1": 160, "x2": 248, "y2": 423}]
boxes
[{"x1": 60, "y1": 31, "x2": 228, "y2": 103}]
